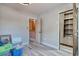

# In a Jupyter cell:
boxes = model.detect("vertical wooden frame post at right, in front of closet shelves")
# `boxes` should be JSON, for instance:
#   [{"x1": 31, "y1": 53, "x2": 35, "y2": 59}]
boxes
[{"x1": 73, "y1": 3, "x2": 78, "y2": 56}]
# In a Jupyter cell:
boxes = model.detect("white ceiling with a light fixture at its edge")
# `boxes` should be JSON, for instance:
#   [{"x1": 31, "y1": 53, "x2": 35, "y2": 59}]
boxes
[{"x1": 1, "y1": 3, "x2": 65, "y2": 14}]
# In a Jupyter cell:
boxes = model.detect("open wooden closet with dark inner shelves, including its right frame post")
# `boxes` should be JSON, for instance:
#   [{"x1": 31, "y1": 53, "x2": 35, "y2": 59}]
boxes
[{"x1": 59, "y1": 3, "x2": 78, "y2": 55}]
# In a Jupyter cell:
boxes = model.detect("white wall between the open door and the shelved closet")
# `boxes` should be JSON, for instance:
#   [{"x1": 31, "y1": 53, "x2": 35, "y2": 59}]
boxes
[{"x1": 39, "y1": 4, "x2": 72, "y2": 49}]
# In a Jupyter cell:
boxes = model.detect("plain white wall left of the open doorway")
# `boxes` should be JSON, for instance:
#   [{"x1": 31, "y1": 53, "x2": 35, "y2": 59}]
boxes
[{"x1": 0, "y1": 5, "x2": 36, "y2": 44}]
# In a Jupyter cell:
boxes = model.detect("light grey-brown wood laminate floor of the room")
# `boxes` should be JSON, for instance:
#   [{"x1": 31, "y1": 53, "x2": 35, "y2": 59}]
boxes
[{"x1": 24, "y1": 42, "x2": 72, "y2": 56}]
